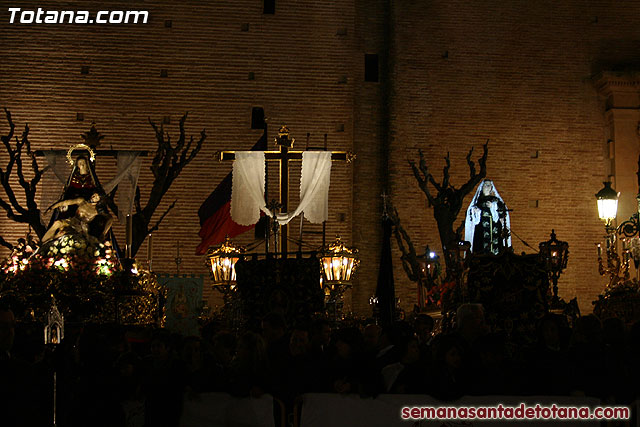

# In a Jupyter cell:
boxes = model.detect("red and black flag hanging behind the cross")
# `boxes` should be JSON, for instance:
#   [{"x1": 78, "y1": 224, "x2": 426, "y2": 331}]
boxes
[{"x1": 196, "y1": 126, "x2": 267, "y2": 255}]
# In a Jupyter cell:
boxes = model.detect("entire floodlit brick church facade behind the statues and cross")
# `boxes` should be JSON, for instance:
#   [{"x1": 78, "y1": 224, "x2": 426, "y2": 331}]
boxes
[{"x1": 0, "y1": 0, "x2": 640, "y2": 315}]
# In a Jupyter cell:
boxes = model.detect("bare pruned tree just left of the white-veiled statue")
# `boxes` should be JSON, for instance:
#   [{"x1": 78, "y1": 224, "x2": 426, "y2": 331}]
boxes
[{"x1": 391, "y1": 140, "x2": 489, "y2": 274}]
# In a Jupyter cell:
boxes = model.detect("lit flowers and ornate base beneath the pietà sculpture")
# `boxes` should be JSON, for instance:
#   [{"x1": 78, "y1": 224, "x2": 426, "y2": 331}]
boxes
[{"x1": 0, "y1": 236, "x2": 162, "y2": 324}]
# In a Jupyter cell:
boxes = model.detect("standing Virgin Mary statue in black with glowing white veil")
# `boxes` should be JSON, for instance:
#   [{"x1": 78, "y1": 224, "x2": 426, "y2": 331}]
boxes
[{"x1": 464, "y1": 179, "x2": 511, "y2": 255}]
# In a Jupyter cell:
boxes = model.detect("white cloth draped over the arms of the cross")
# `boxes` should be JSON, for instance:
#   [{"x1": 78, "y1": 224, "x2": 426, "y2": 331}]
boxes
[{"x1": 231, "y1": 151, "x2": 331, "y2": 229}]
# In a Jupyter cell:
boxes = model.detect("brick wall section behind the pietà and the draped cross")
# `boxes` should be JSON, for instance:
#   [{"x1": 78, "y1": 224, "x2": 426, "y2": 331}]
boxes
[{"x1": 0, "y1": 0, "x2": 354, "y2": 310}]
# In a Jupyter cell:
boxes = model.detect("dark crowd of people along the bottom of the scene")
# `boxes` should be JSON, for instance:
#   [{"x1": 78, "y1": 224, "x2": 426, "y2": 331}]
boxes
[{"x1": 0, "y1": 304, "x2": 640, "y2": 427}]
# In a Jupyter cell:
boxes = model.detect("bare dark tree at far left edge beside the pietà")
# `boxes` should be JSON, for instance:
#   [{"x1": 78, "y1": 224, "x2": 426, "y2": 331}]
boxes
[{"x1": 0, "y1": 108, "x2": 47, "y2": 242}]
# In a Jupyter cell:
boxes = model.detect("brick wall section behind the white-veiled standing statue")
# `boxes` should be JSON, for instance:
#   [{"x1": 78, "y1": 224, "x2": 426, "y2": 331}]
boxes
[{"x1": 391, "y1": 1, "x2": 640, "y2": 313}]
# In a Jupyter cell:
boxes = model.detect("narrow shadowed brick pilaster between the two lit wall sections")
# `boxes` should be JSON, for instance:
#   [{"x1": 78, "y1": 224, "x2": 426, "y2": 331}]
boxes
[{"x1": 352, "y1": 0, "x2": 389, "y2": 315}]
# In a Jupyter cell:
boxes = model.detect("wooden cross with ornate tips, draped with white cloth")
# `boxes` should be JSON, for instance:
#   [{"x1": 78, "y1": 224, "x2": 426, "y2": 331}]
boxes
[{"x1": 219, "y1": 125, "x2": 355, "y2": 257}]
